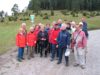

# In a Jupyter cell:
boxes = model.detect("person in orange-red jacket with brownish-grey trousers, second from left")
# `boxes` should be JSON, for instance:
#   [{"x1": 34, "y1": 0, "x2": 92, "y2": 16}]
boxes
[{"x1": 27, "y1": 27, "x2": 37, "y2": 59}]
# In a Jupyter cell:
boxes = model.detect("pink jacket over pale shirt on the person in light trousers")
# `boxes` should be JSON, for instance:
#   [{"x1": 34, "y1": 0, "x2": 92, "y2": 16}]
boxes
[{"x1": 72, "y1": 30, "x2": 87, "y2": 48}]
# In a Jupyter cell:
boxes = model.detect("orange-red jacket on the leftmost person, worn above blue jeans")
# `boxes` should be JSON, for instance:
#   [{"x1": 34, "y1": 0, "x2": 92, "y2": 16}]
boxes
[{"x1": 16, "y1": 33, "x2": 26, "y2": 47}]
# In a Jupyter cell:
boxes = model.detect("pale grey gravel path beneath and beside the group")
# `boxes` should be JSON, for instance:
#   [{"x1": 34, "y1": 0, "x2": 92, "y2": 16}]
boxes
[{"x1": 0, "y1": 30, "x2": 100, "y2": 75}]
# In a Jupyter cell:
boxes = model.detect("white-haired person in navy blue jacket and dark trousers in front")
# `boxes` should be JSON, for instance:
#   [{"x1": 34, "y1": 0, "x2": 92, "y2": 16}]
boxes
[{"x1": 57, "y1": 24, "x2": 70, "y2": 66}]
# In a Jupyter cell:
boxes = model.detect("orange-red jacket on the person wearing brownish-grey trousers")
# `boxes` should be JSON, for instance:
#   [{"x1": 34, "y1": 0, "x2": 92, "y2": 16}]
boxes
[{"x1": 27, "y1": 32, "x2": 37, "y2": 46}]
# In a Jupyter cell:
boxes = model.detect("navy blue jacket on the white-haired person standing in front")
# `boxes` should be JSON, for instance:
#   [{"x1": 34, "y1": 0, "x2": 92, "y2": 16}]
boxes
[{"x1": 57, "y1": 30, "x2": 70, "y2": 47}]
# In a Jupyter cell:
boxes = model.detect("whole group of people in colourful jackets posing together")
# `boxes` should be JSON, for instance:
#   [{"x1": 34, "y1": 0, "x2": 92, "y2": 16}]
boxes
[{"x1": 16, "y1": 18, "x2": 88, "y2": 69}]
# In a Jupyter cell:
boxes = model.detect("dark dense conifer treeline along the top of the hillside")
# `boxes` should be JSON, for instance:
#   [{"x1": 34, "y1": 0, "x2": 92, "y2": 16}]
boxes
[{"x1": 28, "y1": 0, "x2": 100, "y2": 11}]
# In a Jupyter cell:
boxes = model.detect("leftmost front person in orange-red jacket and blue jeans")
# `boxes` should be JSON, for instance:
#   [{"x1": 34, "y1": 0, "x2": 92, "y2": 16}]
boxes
[{"x1": 16, "y1": 28, "x2": 26, "y2": 62}]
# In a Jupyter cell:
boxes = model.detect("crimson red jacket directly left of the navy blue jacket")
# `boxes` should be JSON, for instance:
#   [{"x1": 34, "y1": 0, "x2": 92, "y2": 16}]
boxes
[{"x1": 50, "y1": 29, "x2": 60, "y2": 44}]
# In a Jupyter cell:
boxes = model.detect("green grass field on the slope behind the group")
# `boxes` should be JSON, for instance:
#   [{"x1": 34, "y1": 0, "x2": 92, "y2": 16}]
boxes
[{"x1": 0, "y1": 11, "x2": 100, "y2": 54}]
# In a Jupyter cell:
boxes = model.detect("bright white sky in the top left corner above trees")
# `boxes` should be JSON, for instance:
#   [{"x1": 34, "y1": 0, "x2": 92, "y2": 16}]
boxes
[{"x1": 0, "y1": 0, "x2": 30, "y2": 15}]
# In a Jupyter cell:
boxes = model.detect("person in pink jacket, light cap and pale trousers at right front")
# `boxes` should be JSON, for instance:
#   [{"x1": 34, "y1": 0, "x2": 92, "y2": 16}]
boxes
[{"x1": 72, "y1": 24, "x2": 87, "y2": 69}]
